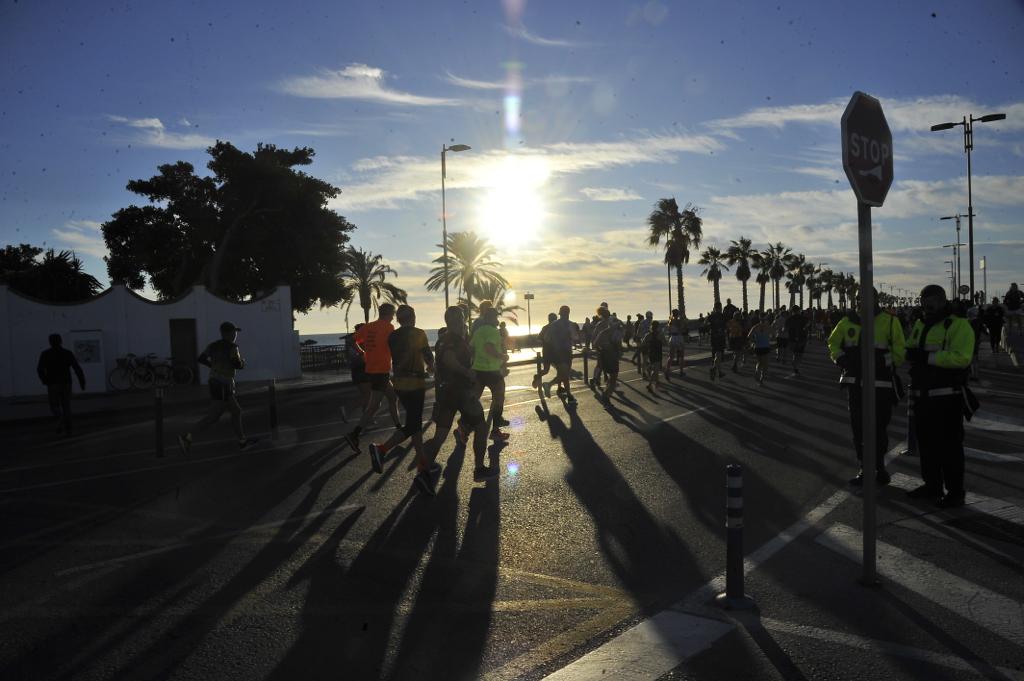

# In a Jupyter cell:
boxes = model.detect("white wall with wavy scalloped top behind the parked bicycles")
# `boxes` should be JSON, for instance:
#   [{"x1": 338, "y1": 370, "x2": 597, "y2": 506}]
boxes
[{"x1": 0, "y1": 286, "x2": 302, "y2": 396}]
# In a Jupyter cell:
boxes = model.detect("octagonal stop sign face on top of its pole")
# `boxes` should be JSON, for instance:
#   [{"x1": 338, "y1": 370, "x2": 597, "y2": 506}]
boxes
[{"x1": 843, "y1": 90, "x2": 893, "y2": 206}]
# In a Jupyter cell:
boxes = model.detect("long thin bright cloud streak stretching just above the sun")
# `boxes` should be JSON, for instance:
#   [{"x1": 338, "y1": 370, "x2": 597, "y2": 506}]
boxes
[{"x1": 331, "y1": 135, "x2": 722, "y2": 210}]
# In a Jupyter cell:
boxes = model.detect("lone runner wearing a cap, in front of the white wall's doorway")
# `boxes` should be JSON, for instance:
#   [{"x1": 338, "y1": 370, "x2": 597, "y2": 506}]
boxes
[{"x1": 178, "y1": 322, "x2": 254, "y2": 455}]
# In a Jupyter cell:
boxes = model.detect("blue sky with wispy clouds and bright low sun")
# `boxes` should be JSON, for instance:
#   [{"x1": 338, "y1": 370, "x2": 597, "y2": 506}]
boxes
[{"x1": 0, "y1": 0, "x2": 1024, "y2": 333}]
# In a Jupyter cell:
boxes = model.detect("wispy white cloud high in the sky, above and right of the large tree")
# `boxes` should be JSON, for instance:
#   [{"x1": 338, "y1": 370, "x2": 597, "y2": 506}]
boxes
[{"x1": 279, "y1": 63, "x2": 461, "y2": 107}]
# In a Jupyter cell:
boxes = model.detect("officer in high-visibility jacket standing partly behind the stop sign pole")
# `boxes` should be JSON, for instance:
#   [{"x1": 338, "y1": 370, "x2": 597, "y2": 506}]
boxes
[{"x1": 828, "y1": 292, "x2": 906, "y2": 486}]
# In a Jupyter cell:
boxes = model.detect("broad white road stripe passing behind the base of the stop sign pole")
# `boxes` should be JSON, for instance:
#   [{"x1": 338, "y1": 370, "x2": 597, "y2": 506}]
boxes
[{"x1": 815, "y1": 524, "x2": 1024, "y2": 645}]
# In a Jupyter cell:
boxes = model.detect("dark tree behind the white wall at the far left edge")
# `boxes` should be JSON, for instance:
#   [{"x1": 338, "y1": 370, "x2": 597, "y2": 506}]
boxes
[{"x1": 0, "y1": 244, "x2": 102, "y2": 303}]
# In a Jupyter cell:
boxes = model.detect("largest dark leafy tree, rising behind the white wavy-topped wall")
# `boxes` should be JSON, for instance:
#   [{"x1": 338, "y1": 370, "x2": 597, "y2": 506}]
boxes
[{"x1": 102, "y1": 141, "x2": 354, "y2": 312}]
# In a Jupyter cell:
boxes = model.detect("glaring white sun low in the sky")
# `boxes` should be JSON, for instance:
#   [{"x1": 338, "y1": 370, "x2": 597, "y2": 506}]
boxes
[{"x1": 477, "y1": 155, "x2": 551, "y2": 249}]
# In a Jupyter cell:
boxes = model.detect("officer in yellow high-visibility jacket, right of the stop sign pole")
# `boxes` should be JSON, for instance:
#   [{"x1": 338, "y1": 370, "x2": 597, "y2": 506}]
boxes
[{"x1": 906, "y1": 284, "x2": 974, "y2": 508}]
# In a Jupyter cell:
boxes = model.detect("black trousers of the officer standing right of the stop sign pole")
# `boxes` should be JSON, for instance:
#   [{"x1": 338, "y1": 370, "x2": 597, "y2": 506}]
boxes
[{"x1": 913, "y1": 394, "x2": 964, "y2": 496}]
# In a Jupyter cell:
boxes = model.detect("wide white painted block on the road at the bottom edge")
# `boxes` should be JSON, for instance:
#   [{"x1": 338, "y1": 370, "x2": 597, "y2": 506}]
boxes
[{"x1": 546, "y1": 610, "x2": 733, "y2": 681}]
